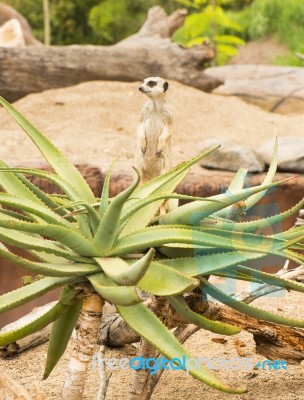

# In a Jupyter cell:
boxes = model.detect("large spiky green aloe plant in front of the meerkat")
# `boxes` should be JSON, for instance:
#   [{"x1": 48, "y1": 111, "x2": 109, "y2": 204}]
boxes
[{"x1": 0, "y1": 98, "x2": 304, "y2": 399}]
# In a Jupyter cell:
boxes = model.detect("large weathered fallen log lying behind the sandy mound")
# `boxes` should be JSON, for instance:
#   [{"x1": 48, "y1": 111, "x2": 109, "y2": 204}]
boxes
[{"x1": 0, "y1": 7, "x2": 221, "y2": 101}]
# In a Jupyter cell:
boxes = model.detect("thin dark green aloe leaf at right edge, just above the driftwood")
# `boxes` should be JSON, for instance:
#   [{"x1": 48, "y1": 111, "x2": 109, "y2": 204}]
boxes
[{"x1": 230, "y1": 265, "x2": 304, "y2": 292}]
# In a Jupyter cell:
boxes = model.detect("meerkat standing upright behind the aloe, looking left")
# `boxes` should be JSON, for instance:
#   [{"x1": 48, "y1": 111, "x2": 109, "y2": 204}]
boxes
[{"x1": 137, "y1": 77, "x2": 172, "y2": 183}]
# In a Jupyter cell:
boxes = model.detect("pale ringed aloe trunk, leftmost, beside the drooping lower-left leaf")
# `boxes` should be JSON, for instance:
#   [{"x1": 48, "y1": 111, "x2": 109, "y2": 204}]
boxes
[{"x1": 61, "y1": 293, "x2": 104, "y2": 400}]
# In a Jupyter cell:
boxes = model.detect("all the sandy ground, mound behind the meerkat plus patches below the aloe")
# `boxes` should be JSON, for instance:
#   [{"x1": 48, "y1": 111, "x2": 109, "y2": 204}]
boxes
[{"x1": 0, "y1": 74, "x2": 304, "y2": 400}]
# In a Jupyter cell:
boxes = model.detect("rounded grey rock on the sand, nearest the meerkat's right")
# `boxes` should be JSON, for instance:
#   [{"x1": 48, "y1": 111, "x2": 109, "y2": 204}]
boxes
[{"x1": 200, "y1": 138, "x2": 265, "y2": 172}]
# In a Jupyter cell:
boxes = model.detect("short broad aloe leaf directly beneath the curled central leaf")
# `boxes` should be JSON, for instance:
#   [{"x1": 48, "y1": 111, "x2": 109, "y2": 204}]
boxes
[{"x1": 87, "y1": 272, "x2": 142, "y2": 306}]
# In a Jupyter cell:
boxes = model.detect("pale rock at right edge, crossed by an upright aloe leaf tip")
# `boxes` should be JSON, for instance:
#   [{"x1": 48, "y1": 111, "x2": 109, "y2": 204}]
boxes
[{"x1": 259, "y1": 136, "x2": 304, "y2": 173}]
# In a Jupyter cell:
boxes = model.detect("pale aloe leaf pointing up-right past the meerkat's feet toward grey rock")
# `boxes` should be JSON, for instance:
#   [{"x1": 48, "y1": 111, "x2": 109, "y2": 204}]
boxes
[{"x1": 121, "y1": 146, "x2": 220, "y2": 236}]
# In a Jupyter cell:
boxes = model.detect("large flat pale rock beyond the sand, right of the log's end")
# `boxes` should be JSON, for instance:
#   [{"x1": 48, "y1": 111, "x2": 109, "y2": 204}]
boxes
[{"x1": 205, "y1": 65, "x2": 304, "y2": 114}]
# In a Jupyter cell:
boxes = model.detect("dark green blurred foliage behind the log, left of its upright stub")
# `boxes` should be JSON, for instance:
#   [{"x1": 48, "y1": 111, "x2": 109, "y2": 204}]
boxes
[{"x1": 6, "y1": 0, "x2": 175, "y2": 45}]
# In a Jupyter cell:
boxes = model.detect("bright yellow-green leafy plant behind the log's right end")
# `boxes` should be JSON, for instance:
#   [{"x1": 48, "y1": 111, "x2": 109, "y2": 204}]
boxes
[{"x1": 174, "y1": 0, "x2": 245, "y2": 65}]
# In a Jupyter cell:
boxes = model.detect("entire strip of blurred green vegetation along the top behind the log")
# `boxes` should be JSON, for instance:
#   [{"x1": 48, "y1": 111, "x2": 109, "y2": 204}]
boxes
[{"x1": 5, "y1": 0, "x2": 304, "y2": 65}]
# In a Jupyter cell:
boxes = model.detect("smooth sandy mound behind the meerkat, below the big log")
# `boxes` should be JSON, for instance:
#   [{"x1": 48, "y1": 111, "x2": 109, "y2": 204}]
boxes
[{"x1": 0, "y1": 82, "x2": 304, "y2": 173}]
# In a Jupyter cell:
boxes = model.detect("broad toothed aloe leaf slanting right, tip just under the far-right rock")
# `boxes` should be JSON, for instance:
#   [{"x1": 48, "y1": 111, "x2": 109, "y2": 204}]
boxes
[{"x1": 159, "y1": 181, "x2": 283, "y2": 225}]
